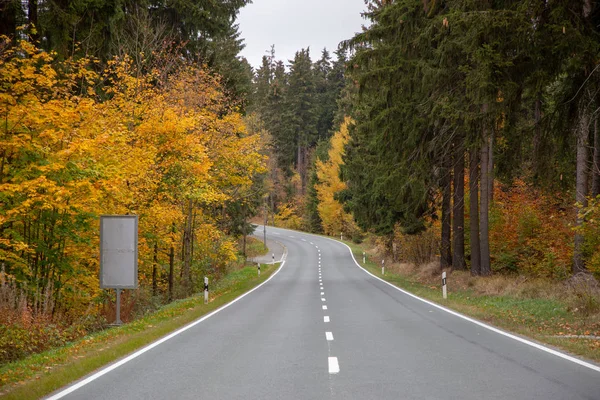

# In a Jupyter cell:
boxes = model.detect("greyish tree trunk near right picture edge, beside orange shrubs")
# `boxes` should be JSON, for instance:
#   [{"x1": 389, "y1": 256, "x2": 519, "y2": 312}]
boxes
[{"x1": 573, "y1": 111, "x2": 589, "y2": 274}]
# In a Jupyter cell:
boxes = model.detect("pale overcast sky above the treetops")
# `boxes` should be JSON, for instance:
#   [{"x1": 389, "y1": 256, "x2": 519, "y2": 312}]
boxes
[{"x1": 237, "y1": 0, "x2": 366, "y2": 67}]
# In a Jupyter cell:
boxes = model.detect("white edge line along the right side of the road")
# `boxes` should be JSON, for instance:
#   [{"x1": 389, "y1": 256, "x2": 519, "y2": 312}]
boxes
[{"x1": 320, "y1": 236, "x2": 600, "y2": 372}]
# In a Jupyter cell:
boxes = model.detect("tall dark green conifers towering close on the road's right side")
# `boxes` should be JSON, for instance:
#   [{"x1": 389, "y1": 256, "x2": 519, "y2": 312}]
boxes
[{"x1": 343, "y1": 0, "x2": 600, "y2": 275}]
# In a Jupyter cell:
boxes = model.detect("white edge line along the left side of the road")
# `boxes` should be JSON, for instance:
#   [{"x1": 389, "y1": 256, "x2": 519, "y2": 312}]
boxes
[{"x1": 46, "y1": 246, "x2": 287, "y2": 400}]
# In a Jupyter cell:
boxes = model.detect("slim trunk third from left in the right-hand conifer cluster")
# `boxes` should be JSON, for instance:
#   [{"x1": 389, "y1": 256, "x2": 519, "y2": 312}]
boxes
[{"x1": 469, "y1": 148, "x2": 481, "y2": 275}]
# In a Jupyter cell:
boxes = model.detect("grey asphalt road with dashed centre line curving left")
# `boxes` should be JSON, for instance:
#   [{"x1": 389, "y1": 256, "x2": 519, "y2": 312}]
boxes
[{"x1": 49, "y1": 227, "x2": 600, "y2": 400}]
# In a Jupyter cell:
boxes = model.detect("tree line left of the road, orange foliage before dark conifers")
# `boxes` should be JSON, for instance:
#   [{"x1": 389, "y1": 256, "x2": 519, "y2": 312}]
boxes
[{"x1": 0, "y1": 0, "x2": 266, "y2": 332}]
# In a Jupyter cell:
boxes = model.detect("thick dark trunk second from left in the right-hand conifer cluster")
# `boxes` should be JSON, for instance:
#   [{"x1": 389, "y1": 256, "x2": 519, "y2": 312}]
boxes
[{"x1": 452, "y1": 138, "x2": 466, "y2": 269}]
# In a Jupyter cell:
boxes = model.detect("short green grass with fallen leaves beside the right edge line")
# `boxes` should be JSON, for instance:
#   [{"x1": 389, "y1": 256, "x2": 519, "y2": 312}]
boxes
[{"x1": 344, "y1": 241, "x2": 600, "y2": 362}]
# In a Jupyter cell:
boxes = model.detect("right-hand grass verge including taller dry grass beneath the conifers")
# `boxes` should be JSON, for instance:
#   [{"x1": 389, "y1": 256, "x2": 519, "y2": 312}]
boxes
[{"x1": 344, "y1": 241, "x2": 600, "y2": 362}]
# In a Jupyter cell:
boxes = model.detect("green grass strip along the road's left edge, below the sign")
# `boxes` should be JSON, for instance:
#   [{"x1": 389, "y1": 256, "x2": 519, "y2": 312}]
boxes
[{"x1": 0, "y1": 264, "x2": 279, "y2": 400}]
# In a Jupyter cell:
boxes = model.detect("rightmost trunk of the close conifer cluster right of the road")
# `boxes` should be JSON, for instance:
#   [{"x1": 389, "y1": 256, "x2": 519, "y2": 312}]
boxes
[{"x1": 479, "y1": 129, "x2": 492, "y2": 276}]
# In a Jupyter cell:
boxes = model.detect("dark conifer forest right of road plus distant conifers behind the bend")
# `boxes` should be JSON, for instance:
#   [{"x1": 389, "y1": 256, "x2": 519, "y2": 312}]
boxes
[{"x1": 254, "y1": 0, "x2": 600, "y2": 275}]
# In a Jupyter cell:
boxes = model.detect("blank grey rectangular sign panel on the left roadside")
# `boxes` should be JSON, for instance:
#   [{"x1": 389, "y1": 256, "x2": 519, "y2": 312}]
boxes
[{"x1": 100, "y1": 215, "x2": 138, "y2": 289}]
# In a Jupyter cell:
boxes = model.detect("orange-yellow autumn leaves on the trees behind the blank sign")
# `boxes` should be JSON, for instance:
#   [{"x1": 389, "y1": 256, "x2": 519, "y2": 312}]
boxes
[{"x1": 0, "y1": 37, "x2": 265, "y2": 318}]
